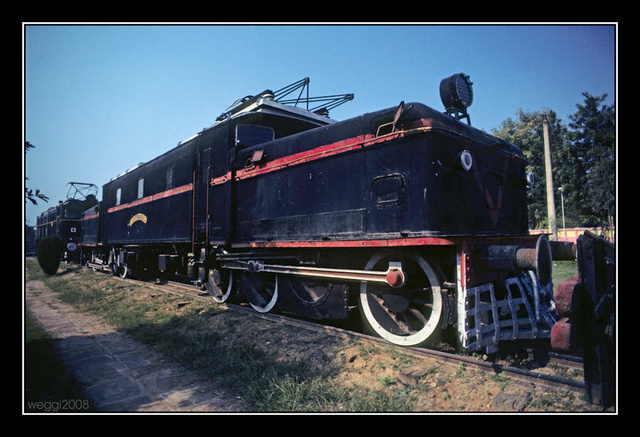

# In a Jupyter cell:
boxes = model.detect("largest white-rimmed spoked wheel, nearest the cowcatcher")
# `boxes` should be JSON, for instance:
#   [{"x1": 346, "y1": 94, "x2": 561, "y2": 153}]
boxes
[{"x1": 359, "y1": 252, "x2": 444, "y2": 346}]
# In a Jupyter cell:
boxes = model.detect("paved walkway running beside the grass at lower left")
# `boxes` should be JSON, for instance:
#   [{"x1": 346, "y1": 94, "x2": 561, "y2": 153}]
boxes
[{"x1": 26, "y1": 281, "x2": 246, "y2": 413}]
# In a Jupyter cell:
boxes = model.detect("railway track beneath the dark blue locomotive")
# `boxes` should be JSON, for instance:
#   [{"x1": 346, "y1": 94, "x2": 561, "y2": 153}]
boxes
[{"x1": 117, "y1": 272, "x2": 585, "y2": 394}]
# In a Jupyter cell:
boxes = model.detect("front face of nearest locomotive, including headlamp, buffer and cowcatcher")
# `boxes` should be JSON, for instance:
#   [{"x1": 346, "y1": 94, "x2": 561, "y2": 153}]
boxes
[{"x1": 434, "y1": 73, "x2": 561, "y2": 353}]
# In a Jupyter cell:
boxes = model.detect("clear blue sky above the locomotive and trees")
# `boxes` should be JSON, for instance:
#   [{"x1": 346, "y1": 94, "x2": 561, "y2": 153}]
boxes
[{"x1": 22, "y1": 23, "x2": 617, "y2": 224}]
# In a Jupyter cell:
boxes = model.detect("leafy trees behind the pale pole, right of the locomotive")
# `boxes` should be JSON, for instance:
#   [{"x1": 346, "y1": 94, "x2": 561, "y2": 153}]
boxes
[{"x1": 492, "y1": 92, "x2": 615, "y2": 229}]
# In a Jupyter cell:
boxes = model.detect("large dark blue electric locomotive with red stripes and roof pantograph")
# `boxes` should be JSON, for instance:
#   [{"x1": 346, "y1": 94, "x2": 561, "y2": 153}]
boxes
[{"x1": 85, "y1": 73, "x2": 555, "y2": 352}]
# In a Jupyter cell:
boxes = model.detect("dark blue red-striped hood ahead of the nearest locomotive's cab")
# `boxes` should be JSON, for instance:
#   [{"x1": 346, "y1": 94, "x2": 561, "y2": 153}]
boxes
[{"x1": 230, "y1": 103, "x2": 528, "y2": 245}]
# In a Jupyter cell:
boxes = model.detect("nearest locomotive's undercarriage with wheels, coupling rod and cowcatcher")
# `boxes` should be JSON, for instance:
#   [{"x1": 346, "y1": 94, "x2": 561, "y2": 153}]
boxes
[{"x1": 87, "y1": 233, "x2": 555, "y2": 353}]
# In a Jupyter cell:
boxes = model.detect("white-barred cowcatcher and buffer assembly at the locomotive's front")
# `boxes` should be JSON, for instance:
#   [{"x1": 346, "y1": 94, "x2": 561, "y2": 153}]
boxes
[{"x1": 456, "y1": 235, "x2": 556, "y2": 353}]
